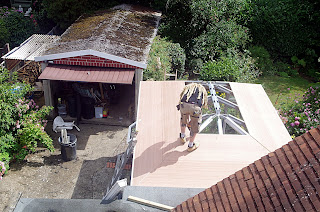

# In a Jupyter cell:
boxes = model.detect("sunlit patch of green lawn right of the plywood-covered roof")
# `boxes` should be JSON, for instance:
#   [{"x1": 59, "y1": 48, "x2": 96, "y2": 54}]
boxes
[{"x1": 254, "y1": 76, "x2": 320, "y2": 109}]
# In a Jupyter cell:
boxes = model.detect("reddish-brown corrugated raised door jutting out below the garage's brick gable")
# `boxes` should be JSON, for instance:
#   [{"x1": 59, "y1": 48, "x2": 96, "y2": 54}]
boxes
[{"x1": 39, "y1": 65, "x2": 134, "y2": 84}]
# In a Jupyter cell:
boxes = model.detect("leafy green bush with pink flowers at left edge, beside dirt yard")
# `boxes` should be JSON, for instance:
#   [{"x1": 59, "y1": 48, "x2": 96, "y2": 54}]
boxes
[{"x1": 0, "y1": 68, "x2": 54, "y2": 171}]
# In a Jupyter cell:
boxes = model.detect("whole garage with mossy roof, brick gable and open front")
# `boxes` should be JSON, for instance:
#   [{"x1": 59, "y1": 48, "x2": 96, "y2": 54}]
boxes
[{"x1": 34, "y1": 5, "x2": 161, "y2": 126}]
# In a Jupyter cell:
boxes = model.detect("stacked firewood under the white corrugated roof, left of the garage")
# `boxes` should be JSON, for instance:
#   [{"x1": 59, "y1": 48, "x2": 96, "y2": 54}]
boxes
[{"x1": 17, "y1": 61, "x2": 41, "y2": 85}]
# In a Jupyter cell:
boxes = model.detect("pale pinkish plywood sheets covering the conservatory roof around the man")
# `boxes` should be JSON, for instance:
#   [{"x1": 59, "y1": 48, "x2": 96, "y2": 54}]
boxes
[{"x1": 131, "y1": 81, "x2": 291, "y2": 188}]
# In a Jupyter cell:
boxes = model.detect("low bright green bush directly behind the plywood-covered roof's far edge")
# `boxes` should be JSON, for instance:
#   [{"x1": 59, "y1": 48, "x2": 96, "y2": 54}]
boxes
[{"x1": 200, "y1": 50, "x2": 260, "y2": 82}]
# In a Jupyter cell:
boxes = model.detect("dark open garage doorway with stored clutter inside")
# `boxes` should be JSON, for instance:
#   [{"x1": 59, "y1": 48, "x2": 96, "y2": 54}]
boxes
[{"x1": 51, "y1": 80, "x2": 135, "y2": 126}]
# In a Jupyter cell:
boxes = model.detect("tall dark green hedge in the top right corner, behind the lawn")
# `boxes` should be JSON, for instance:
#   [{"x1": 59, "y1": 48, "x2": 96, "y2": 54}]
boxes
[{"x1": 248, "y1": 0, "x2": 320, "y2": 57}]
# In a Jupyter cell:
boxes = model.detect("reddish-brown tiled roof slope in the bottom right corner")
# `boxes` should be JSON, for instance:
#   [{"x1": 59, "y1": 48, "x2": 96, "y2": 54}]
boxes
[{"x1": 173, "y1": 126, "x2": 320, "y2": 212}]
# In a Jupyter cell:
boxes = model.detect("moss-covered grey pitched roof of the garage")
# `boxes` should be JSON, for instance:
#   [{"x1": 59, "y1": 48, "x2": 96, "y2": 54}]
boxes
[{"x1": 44, "y1": 5, "x2": 161, "y2": 63}]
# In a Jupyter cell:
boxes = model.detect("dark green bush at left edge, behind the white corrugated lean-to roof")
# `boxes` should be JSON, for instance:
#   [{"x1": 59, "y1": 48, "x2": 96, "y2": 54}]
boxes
[{"x1": 0, "y1": 7, "x2": 38, "y2": 48}]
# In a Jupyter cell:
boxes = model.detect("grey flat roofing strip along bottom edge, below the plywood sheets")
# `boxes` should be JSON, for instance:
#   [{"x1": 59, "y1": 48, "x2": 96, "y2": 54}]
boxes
[{"x1": 14, "y1": 186, "x2": 203, "y2": 212}]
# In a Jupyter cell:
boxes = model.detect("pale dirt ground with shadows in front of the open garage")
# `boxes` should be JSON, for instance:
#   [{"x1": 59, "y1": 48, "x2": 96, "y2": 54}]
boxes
[{"x1": 0, "y1": 123, "x2": 130, "y2": 212}]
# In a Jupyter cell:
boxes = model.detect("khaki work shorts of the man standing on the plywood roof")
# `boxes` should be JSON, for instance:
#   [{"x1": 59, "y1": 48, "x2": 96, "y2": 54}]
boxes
[{"x1": 180, "y1": 102, "x2": 202, "y2": 136}]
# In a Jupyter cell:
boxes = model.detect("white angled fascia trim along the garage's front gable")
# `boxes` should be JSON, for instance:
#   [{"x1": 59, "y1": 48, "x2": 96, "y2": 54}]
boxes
[{"x1": 34, "y1": 49, "x2": 147, "y2": 69}]
